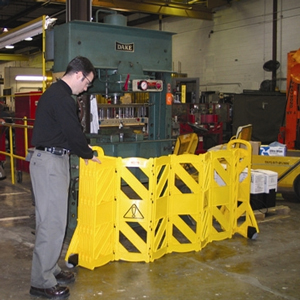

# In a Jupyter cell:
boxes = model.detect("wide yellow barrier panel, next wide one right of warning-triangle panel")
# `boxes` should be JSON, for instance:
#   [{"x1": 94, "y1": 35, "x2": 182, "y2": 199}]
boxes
[{"x1": 167, "y1": 154, "x2": 206, "y2": 253}]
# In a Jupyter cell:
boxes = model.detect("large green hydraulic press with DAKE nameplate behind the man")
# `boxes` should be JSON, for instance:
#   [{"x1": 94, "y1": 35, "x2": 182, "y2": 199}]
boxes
[{"x1": 53, "y1": 21, "x2": 174, "y2": 231}]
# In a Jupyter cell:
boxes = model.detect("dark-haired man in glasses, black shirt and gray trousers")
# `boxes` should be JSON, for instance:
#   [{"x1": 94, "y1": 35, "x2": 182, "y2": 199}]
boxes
[{"x1": 30, "y1": 56, "x2": 101, "y2": 299}]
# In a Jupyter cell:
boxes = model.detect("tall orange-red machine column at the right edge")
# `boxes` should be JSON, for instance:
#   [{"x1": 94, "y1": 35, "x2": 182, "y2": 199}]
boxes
[{"x1": 278, "y1": 49, "x2": 300, "y2": 149}]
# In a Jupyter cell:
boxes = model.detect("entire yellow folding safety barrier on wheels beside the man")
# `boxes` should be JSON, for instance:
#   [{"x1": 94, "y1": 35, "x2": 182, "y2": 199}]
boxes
[{"x1": 66, "y1": 140, "x2": 258, "y2": 269}]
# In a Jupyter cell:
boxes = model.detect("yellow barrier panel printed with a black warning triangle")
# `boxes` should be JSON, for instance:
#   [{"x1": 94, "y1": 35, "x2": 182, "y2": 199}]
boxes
[{"x1": 115, "y1": 157, "x2": 153, "y2": 262}]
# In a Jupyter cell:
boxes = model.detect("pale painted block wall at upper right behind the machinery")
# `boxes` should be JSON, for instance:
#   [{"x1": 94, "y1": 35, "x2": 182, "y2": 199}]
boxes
[{"x1": 134, "y1": 0, "x2": 300, "y2": 93}]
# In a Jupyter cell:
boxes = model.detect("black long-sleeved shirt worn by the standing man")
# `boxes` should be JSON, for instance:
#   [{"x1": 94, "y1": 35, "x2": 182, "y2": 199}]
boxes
[{"x1": 32, "y1": 80, "x2": 93, "y2": 159}]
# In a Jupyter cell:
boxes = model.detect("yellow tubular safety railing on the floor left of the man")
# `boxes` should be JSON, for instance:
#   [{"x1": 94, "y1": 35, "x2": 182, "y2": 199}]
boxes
[{"x1": 0, "y1": 117, "x2": 33, "y2": 184}]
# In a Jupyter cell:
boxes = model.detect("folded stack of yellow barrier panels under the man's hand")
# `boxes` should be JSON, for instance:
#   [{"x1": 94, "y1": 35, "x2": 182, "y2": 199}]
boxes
[{"x1": 69, "y1": 148, "x2": 118, "y2": 269}]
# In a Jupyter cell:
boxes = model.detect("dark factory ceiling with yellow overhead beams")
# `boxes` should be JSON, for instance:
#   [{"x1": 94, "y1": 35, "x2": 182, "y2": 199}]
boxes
[{"x1": 0, "y1": 0, "x2": 232, "y2": 60}]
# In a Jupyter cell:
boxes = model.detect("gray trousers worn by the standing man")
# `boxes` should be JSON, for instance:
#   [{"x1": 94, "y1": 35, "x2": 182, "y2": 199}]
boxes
[{"x1": 29, "y1": 150, "x2": 70, "y2": 288}]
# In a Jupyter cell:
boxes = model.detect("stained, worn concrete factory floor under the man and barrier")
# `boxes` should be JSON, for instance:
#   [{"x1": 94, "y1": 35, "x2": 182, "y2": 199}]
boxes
[{"x1": 0, "y1": 162, "x2": 300, "y2": 300}]
